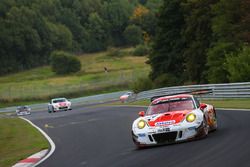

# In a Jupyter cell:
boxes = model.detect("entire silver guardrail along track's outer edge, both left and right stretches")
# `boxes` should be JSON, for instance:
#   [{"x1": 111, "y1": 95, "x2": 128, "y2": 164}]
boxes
[{"x1": 0, "y1": 82, "x2": 250, "y2": 112}]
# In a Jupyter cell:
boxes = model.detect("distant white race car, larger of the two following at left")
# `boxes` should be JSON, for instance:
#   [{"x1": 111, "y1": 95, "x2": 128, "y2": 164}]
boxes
[{"x1": 48, "y1": 98, "x2": 71, "y2": 113}]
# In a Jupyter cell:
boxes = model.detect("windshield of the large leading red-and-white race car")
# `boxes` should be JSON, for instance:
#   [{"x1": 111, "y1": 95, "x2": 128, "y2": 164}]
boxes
[{"x1": 146, "y1": 97, "x2": 195, "y2": 115}]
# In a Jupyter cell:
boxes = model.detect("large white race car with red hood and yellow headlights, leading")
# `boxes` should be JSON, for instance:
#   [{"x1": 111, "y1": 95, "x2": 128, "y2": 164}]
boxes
[{"x1": 132, "y1": 94, "x2": 217, "y2": 148}]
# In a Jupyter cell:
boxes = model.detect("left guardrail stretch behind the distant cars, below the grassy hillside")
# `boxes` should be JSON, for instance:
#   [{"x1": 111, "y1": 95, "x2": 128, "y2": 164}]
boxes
[{"x1": 0, "y1": 91, "x2": 127, "y2": 112}]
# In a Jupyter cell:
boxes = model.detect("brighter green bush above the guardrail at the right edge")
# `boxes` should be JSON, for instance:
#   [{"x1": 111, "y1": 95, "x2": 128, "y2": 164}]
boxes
[{"x1": 225, "y1": 46, "x2": 250, "y2": 82}]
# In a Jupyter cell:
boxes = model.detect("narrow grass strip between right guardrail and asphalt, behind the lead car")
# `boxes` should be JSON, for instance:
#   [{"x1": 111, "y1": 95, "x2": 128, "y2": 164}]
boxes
[{"x1": 112, "y1": 99, "x2": 250, "y2": 109}]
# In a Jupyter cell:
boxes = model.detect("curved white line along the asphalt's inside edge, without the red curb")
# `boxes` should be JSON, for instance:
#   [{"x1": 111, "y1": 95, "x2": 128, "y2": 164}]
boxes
[{"x1": 19, "y1": 117, "x2": 56, "y2": 167}]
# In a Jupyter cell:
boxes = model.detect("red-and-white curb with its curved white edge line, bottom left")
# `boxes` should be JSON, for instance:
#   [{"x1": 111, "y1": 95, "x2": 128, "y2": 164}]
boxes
[{"x1": 12, "y1": 117, "x2": 56, "y2": 167}]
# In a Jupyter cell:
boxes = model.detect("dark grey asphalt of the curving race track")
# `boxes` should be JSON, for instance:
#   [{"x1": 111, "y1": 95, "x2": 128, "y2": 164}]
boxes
[{"x1": 23, "y1": 106, "x2": 250, "y2": 167}]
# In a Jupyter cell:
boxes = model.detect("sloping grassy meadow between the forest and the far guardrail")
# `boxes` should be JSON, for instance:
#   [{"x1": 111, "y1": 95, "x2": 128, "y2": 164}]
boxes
[{"x1": 0, "y1": 48, "x2": 150, "y2": 107}]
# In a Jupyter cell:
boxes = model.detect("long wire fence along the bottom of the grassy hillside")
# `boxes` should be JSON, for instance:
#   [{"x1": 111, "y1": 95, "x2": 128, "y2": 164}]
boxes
[{"x1": 0, "y1": 72, "x2": 144, "y2": 101}]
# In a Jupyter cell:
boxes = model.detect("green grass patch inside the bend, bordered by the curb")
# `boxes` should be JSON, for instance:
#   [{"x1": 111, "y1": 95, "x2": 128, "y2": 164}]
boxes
[{"x1": 0, "y1": 118, "x2": 49, "y2": 167}]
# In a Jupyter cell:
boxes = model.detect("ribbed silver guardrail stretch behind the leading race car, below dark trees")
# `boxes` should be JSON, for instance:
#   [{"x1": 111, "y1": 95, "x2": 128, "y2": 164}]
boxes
[{"x1": 136, "y1": 82, "x2": 250, "y2": 100}]
